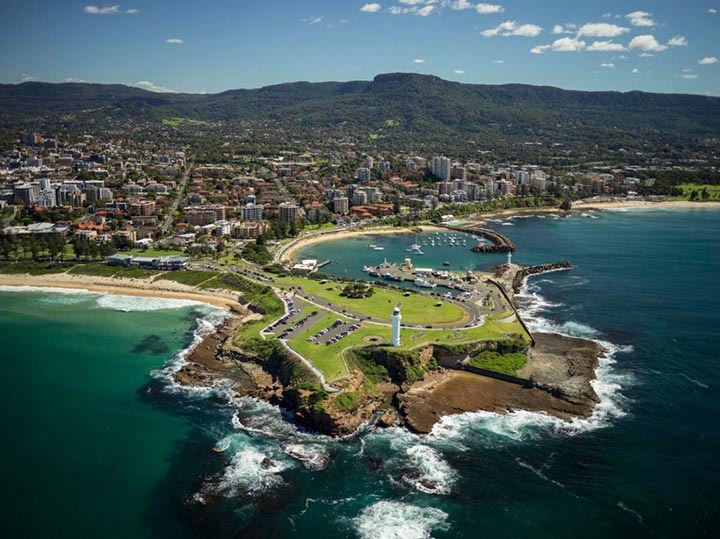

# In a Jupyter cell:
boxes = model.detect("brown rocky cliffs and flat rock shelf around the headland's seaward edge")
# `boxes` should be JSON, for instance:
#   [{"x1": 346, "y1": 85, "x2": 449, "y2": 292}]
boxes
[{"x1": 175, "y1": 306, "x2": 603, "y2": 436}]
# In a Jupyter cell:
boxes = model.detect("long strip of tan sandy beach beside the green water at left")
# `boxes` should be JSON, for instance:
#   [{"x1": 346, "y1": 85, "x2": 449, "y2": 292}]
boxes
[{"x1": 0, "y1": 273, "x2": 245, "y2": 313}]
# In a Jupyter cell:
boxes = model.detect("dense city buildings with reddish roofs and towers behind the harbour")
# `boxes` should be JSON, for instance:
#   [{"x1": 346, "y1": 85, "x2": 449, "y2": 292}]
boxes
[{"x1": 0, "y1": 133, "x2": 652, "y2": 262}]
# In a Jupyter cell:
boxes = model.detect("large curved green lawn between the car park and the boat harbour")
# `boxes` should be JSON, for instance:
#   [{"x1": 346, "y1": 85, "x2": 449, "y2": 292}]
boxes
[{"x1": 277, "y1": 277, "x2": 468, "y2": 325}]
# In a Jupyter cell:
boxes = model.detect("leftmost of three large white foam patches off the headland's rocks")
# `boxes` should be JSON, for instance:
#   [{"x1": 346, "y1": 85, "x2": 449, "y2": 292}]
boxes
[{"x1": 217, "y1": 446, "x2": 289, "y2": 496}]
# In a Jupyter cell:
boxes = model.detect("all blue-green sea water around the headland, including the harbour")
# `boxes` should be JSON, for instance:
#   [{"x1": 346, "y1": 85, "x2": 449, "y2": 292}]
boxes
[{"x1": 0, "y1": 209, "x2": 720, "y2": 538}]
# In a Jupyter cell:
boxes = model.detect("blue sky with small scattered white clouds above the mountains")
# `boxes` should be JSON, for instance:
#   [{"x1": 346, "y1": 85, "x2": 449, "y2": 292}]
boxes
[{"x1": 0, "y1": 0, "x2": 720, "y2": 95}]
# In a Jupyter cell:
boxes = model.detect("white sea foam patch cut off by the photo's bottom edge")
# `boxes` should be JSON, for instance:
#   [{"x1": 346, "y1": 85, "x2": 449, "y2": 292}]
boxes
[{"x1": 353, "y1": 501, "x2": 449, "y2": 539}]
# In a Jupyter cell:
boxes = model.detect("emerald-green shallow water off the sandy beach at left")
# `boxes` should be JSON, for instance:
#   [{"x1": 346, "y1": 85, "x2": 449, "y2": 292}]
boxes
[{"x1": 0, "y1": 293, "x2": 222, "y2": 538}]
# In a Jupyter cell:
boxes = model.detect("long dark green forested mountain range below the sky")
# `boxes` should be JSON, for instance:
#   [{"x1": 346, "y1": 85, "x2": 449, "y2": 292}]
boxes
[{"x1": 0, "y1": 73, "x2": 720, "y2": 155}]
